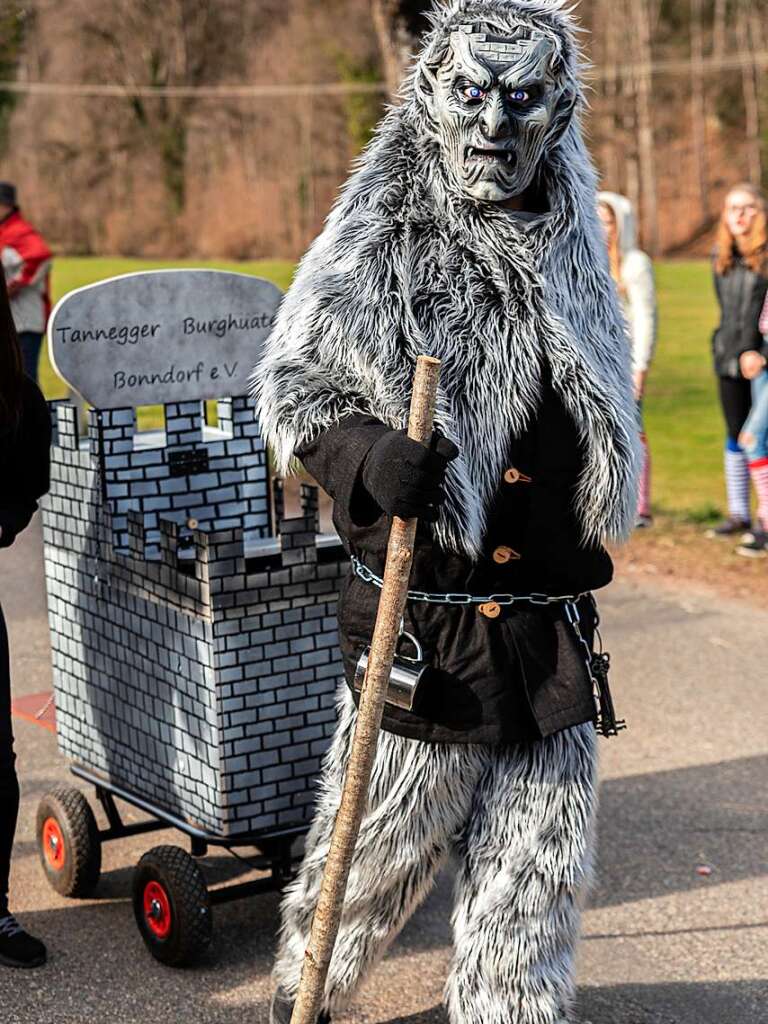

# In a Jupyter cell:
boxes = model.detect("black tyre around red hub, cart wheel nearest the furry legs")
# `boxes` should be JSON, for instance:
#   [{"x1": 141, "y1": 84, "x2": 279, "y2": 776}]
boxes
[{"x1": 133, "y1": 846, "x2": 213, "y2": 967}]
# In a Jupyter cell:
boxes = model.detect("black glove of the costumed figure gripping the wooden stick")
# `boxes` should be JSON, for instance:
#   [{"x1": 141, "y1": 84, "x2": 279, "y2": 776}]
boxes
[{"x1": 362, "y1": 430, "x2": 459, "y2": 522}]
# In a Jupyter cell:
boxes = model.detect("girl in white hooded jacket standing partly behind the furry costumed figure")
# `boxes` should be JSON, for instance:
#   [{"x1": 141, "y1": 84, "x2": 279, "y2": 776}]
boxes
[{"x1": 597, "y1": 191, "x2": 657, "y2": 526}]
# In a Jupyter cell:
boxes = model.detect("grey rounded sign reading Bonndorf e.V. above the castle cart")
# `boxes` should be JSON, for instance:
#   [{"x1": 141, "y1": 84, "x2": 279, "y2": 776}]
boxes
[{"x1": 48, "y1": 270, "x2": 283, "y2": 409}]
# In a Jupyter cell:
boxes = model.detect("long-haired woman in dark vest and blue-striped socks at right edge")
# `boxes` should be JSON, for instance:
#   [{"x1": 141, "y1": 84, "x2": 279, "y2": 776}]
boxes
[{"x1": 712, "y1": 184, "x2": 768, "y2": 537}]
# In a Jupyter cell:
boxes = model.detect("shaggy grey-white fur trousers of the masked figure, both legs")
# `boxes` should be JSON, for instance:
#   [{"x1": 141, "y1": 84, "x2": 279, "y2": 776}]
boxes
[{"x1": 274, "y1": 691, "x2": 596, "y2": 1024}]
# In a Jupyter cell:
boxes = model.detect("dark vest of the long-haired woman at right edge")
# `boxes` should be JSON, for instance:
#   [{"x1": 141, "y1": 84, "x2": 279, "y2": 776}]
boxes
[{"x1": 712, "y1": 256, "x2": 768, "y2": 379}]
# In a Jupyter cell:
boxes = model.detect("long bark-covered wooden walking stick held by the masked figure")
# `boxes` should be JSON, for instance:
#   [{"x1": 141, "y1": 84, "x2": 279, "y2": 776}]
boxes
[{"x1": 291, "y1": 355, "x2": 440, "y2": 1024}]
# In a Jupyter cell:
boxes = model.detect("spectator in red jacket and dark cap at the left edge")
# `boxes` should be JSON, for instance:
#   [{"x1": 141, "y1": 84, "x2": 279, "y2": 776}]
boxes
[{"x1": 0, "y1": 181, "x2": 52, "y2": 381}]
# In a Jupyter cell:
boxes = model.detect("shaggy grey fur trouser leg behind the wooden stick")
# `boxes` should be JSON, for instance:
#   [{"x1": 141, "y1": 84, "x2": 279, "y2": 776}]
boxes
[{"x1": 274, "y1": 687, "x2": 484, "y2": 1010}]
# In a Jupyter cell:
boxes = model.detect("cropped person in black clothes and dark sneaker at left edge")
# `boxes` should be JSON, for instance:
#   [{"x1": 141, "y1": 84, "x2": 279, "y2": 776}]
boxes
[{"x1": 0, "y1": 268, "x2": 51, "y2": 968}]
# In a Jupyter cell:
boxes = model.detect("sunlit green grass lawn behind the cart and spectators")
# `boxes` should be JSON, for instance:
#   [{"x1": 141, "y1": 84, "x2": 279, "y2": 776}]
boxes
[{"x1": 41, "y1": 258, "x2": 724, "y2": 521}]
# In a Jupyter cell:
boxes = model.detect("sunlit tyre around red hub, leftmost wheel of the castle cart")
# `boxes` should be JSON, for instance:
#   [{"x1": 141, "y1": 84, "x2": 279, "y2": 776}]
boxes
[{"x1": 36, "y1": 785, "x2": 101, "y2": 899}]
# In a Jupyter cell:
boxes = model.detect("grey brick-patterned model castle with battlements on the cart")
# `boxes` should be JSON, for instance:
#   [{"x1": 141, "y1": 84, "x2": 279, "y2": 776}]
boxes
[{"x1": 43, "y1": 397, "x2": 346, "y2": 837}]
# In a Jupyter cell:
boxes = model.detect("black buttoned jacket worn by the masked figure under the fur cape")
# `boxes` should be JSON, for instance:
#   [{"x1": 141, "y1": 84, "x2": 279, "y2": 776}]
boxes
[{"x1": 296, "y1": 368, "x2": 612, "y2": 743}]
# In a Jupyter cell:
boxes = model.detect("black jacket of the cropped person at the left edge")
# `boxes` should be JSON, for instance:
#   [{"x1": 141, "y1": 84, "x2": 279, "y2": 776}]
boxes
[{"x1": 0, "y1": 377, "x2": 51, "y2": 548}]
